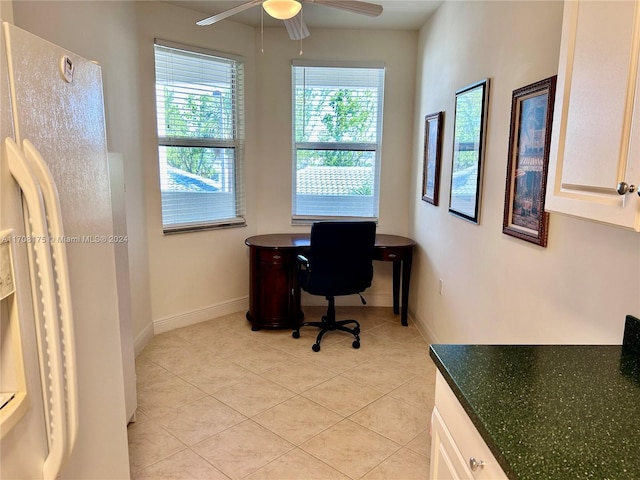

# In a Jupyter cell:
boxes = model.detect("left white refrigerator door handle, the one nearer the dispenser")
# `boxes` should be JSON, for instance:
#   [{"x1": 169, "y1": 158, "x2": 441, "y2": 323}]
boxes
[{"x1": 4, "y1": 138, "x2": 68, "y2": 479}]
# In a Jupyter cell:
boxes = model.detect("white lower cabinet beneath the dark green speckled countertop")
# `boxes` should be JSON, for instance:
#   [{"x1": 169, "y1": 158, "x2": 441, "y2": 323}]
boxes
[{"x1": 429, "y1": 372, "x2": 507, "y2": 480}]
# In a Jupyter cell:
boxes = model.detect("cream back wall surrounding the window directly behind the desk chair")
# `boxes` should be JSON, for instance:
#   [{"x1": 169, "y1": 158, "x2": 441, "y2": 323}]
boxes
[{"x1": 255, "y1": 28, "x2": 417, "y2": 306}]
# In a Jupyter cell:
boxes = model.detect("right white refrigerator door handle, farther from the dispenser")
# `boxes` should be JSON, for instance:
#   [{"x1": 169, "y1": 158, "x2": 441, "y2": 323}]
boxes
[{"x1": 22, "y1": 139, "x2": 79, "y2": 455}]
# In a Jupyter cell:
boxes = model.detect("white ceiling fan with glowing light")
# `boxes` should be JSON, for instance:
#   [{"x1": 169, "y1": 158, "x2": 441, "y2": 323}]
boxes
[{"x1": 196, "y1": 0, "x2": 382, "y2": 40}]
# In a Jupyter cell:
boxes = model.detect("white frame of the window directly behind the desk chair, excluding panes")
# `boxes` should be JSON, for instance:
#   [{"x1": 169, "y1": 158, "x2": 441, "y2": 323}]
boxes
[{"x1": 291, "y1": 59, "x2": 386, "y2": 225}]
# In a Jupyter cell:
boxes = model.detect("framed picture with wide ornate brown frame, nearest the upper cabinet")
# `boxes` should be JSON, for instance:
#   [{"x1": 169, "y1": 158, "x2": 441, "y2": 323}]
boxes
[{"x1": 502, "y1": 76, "x2": 556, "y2": 247}]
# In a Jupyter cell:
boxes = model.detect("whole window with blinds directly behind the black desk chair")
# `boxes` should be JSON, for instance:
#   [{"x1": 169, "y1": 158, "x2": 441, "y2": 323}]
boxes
[{"x1": 292, "y1": 60, "x2": 385, "y2": 223}]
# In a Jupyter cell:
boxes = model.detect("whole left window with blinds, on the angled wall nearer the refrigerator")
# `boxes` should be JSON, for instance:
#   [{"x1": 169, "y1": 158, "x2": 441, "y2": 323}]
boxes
[{"x1": 155, "y1": 40, "x2": 245, "y2": 233}]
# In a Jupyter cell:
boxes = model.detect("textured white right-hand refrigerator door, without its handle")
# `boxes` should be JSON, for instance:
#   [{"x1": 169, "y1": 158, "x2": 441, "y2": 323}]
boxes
[{"x1": 4, "y1": 23, "x2": 129, "y2": 479}]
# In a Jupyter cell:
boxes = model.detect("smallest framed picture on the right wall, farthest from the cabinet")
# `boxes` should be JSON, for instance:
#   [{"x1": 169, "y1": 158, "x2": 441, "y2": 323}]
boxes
[{"x1": 422, "y1": 112, "x2": 444, "y2": 206}]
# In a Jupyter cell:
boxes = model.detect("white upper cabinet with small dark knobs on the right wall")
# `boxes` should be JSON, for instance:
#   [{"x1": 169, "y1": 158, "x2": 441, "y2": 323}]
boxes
[{"x1": 546, "y1": 0, "x2": 640, "y2": 231}]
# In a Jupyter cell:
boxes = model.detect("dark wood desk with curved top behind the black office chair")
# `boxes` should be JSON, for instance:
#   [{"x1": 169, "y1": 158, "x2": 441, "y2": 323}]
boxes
[{"x1": 244, "y1": 233, "x2": 415, "y2": 330}]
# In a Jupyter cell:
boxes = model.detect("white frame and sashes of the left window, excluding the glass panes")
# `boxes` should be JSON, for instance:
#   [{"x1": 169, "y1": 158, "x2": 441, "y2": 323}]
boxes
[{"x1": 154, "y1": 38, "x2": 246, "y2": 234}]
